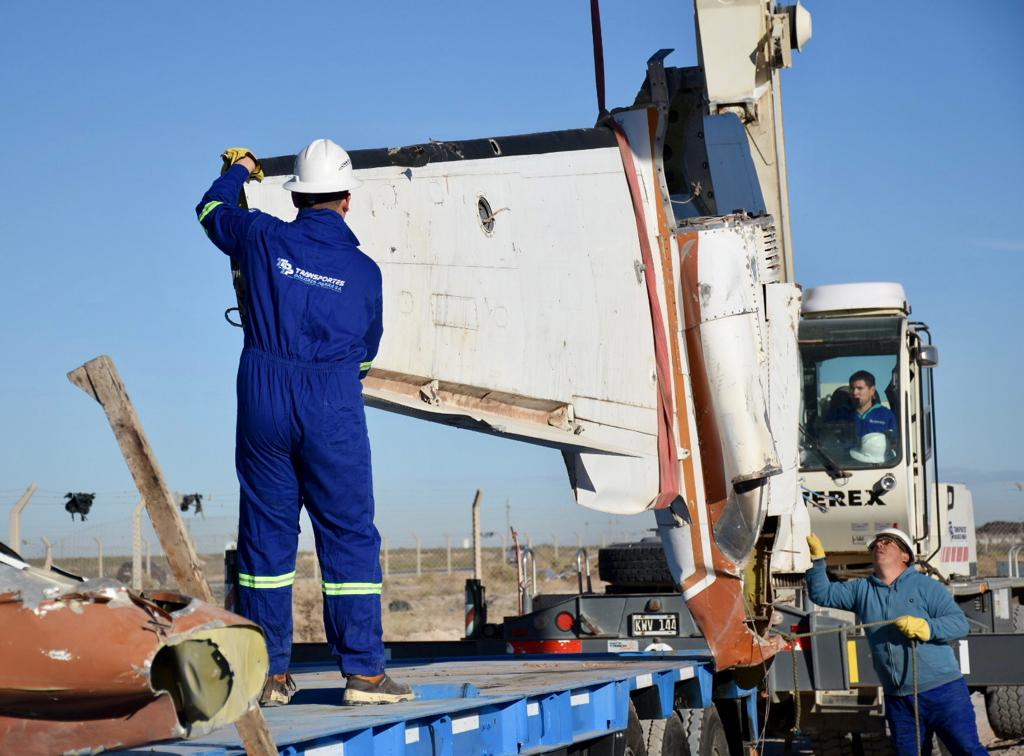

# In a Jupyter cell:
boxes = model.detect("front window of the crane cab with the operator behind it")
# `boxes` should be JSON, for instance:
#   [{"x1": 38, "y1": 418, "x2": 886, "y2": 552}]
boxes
[{"x1": 800, "y1": 318, "x2": 902, "y2": 470}]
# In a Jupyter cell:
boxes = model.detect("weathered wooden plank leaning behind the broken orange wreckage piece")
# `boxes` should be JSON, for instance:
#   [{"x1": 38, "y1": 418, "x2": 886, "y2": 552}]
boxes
[{"x1": 68, "y1": 354, "x2": 278, "y2": 756}]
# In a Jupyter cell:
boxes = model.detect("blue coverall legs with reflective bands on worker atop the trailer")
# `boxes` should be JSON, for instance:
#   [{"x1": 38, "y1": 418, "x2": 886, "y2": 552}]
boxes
[{"x1": 236, "y1": 348, "x2": 384, "y2": 675}]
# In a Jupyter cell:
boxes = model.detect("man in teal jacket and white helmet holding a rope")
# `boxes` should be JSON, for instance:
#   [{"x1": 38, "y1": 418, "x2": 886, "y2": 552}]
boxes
[{"x1": 807, "y1": 528, "x2": 988, "y2": 756}]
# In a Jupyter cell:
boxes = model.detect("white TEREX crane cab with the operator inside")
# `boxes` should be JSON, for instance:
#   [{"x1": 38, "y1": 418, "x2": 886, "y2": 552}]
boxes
[{"x1": 800, "y1": 283, "x2": 976, "y2": 576}]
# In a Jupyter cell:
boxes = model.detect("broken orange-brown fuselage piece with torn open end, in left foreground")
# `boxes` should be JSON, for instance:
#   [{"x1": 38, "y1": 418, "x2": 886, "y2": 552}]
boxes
[{"x1": 0, "y1": 547, "x2": 268, "y2": 754}]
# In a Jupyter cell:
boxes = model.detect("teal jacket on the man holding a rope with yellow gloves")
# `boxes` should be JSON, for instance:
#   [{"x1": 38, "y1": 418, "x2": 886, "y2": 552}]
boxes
[{"x1": 807, "y1": 559, "x2": 969, "y2": 696}]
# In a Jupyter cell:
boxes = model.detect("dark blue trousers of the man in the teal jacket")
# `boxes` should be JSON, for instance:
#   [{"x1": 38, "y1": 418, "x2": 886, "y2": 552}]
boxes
[{"x1": 886, "y1": 677, "x2": 988, "y2": 756}]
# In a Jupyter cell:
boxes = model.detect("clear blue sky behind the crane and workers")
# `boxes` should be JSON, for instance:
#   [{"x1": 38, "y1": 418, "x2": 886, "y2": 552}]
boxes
[{"x1": 0, "y1": 0, "x2": 1024, "y2": 553}]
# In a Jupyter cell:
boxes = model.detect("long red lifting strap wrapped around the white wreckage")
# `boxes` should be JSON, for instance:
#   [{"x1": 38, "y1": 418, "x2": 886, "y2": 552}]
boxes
[{"x1": 590, "y1": 0, "x2": 679, "y2": 509}]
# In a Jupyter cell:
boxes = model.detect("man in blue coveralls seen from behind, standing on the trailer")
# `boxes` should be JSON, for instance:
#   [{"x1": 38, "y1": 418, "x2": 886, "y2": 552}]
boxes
[{"x1": 196, "y1": 139, "x2": 413, "y2": 706}]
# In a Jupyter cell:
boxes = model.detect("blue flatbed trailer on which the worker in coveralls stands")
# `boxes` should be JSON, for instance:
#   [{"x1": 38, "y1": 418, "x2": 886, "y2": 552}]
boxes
[{"x1": 126, "y1": 653, "x2": 757, "y2": 756}]
